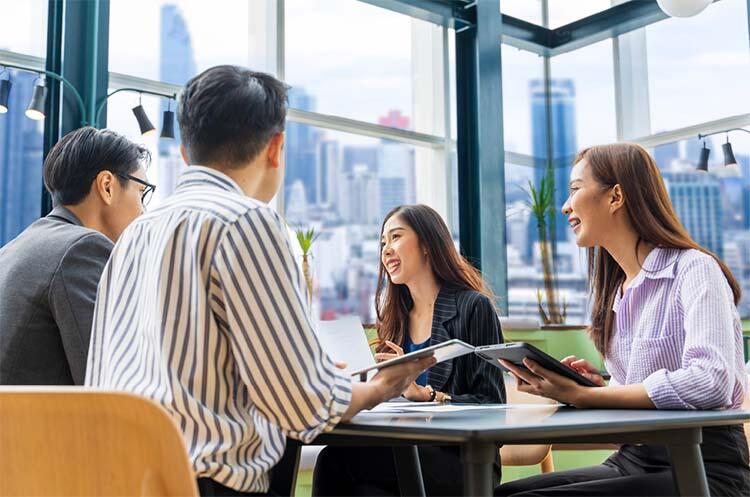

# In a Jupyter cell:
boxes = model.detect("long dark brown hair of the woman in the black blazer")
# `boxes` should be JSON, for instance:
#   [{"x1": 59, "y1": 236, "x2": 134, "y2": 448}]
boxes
[{"x1": 375, "y1": 204, "x2": 495, "y2": 351}]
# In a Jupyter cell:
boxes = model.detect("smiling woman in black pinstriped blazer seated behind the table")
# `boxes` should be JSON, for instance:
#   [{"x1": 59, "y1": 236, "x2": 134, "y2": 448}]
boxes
[{"x1": 313, "y1": 205, "x2": 505, "y2": 495}]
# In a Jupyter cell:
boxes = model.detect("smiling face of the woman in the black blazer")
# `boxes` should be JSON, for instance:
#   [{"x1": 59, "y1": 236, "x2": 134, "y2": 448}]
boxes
[{"x1": 380, "y1": 214, "x2": 432, "y2": 285}]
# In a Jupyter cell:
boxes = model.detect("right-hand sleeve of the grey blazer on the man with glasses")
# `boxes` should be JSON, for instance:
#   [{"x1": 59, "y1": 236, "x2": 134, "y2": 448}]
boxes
[{"x1": 48, "y1": 233, "x2": 112, "y2": 385}]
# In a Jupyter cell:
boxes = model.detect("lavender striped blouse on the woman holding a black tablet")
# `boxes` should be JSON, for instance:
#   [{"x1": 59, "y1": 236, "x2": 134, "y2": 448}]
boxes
[{"x1": 605, "y1": 248, "x2": 747, "y2": 409}]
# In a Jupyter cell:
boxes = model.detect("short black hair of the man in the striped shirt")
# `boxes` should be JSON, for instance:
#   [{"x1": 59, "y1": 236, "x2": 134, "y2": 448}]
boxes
[{"x1": 177, "y1": 65, "x2": 288, "y2": 168}]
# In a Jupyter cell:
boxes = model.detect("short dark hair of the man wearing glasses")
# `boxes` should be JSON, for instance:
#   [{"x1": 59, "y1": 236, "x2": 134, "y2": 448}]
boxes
[{"x1": 44, "y1": 126, "x2": 151, "y2": 205}]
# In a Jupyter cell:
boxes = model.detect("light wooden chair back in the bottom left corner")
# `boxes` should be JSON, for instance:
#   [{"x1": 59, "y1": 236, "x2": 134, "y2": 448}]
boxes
[{"x1": 0, "y1": 387, "x2": 198, "y2": 496}]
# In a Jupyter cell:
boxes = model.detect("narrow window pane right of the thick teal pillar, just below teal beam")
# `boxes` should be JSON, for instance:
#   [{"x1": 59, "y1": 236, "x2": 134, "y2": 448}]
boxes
[{"x1": 502, "y1": 45, "x2": 546, "y2": 156}]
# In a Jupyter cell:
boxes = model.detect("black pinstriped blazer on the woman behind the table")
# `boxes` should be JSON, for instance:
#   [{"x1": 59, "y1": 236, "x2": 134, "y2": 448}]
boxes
[{"x1": 420, "y1": 286, "x2": 505, "y2": 403}]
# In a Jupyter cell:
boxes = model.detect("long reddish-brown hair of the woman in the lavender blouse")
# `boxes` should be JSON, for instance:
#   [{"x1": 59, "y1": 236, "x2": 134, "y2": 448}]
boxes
[{"x1": 575, "y1": 143, "x2": 741, "y2": 355}]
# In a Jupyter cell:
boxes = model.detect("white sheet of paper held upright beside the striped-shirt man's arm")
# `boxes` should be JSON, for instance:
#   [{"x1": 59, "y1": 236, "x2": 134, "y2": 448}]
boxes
[{"x1": 318, "y1": 316, "x2": 375, "y2": 374}]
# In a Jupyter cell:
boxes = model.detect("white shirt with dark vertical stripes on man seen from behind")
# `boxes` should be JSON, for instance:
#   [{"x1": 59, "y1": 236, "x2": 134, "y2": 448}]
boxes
[{"x1": 86, "y1": 166, "x2": 351, "y2": 492}]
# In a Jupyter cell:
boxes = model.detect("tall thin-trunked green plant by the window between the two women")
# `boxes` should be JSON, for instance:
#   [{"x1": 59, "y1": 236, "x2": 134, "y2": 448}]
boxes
[{"x1": 528, "y1": 170, "x2": 567, "y2": 325}]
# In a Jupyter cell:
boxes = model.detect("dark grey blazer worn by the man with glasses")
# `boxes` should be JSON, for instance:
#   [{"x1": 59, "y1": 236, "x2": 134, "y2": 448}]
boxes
[{"x1": 0, "y1": 207, "x2": 113, "y2": 385}]
